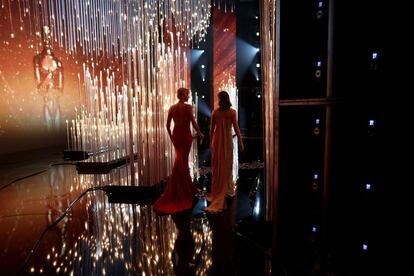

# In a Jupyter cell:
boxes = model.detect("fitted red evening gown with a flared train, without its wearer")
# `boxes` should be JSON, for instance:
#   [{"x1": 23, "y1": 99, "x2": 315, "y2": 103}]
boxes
[{"x1": 153, "y1": 126, "x2": 197, "y2": 214}]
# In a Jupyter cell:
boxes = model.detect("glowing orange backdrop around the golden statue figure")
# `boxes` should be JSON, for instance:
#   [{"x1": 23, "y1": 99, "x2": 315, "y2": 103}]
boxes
[{"x1": 0, "y1": 18, "x2": 82, "y2": 154}]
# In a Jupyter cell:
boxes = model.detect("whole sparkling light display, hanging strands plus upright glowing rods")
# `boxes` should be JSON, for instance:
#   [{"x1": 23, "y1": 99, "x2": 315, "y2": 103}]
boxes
[{"x1": 3, "y1": 0, "x2": 211, "y2": 185}]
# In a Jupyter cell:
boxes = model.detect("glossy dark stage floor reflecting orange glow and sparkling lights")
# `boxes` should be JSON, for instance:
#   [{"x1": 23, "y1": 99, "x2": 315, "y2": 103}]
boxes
[{"x1": 0, "y1": 149, "x2": 269, "y2": 275}]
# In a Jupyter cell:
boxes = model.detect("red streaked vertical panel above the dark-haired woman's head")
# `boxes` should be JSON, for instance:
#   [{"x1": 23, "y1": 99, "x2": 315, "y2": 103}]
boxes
[{"x1": 213, "y1": 7, "x2": 236, "y2": 108}]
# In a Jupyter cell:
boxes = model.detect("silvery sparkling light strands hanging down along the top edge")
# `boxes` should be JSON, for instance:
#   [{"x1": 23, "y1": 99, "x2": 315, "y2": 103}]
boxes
[{"x1": 9, "y1": 0, "x2": 211, "y2": 57}]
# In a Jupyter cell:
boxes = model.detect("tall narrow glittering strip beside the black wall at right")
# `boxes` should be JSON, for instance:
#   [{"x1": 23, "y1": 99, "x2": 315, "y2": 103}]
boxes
[{"x1": 260, "y1": 0, "x2": 280, "y2": 273}]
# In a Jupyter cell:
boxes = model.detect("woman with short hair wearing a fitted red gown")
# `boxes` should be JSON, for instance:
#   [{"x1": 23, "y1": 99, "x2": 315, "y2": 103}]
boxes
[{"x1": 153, "y1": 88, "x2": 204, "y2": 215}]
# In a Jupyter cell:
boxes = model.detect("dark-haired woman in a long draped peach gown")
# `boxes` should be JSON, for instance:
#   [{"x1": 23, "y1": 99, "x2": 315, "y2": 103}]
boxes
[{"x1": 204, "y1": 91, "x2": 244, "y2": 213}]
